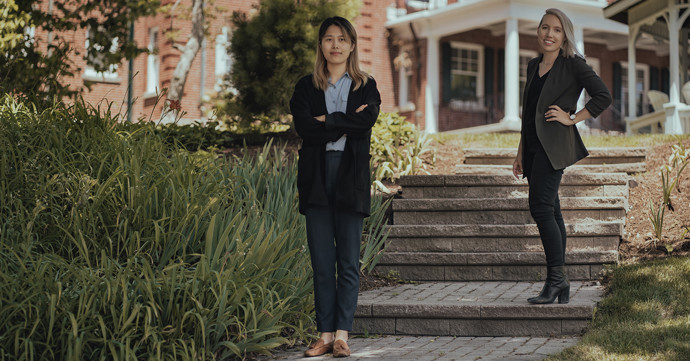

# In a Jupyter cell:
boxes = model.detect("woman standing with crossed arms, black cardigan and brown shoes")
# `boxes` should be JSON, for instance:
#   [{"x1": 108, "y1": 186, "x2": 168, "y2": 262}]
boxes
[{"x1": 290, "y1": 17, "x2": 381, "y2": 357}]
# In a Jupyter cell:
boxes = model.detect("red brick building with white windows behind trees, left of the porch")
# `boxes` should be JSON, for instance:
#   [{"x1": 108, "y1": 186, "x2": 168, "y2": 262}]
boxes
[{"x1": 61, "y1": 0, "x2": 395, "y2": 120}]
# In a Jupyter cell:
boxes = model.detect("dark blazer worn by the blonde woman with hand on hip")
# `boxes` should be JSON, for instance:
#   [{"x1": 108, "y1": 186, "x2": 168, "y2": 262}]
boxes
[{"x1": 522, "y1": 53, "x2": 612, "y2": 169}]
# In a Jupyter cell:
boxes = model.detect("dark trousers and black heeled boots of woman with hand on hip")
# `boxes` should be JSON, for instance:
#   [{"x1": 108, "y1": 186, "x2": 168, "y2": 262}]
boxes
[{"x1": 524, "y1": 147, "x2": 570, "y2": 303}]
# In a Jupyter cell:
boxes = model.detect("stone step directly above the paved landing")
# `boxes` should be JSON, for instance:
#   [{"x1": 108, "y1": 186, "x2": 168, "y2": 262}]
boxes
[{"x1": 374, "y1": 251, "x2": 618, "y2": 281}]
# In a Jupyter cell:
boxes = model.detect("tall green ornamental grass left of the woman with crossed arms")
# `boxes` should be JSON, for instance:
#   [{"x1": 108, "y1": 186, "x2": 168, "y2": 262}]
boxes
[{"x1": 0, "y1": 97, "x2": 388, "y2": 360}]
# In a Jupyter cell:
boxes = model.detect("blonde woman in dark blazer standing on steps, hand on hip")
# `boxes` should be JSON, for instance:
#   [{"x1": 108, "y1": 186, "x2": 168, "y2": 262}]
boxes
[{"x1": 513, "y1": 8, "x2": 611, "y2": 304}]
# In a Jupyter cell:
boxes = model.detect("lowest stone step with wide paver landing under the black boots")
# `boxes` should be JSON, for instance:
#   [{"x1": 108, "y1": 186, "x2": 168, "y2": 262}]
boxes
[{"x1": 353, "y1": 281, "x2": 603, "y2": 337}]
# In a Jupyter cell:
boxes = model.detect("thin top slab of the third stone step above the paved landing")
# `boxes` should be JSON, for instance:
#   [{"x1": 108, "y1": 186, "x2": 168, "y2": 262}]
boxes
[{"x1": 392, "y1": 197, "x2": 627, "y2": 212}]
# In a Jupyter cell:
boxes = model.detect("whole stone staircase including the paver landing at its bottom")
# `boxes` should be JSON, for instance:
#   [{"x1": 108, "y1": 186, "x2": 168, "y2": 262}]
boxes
[{"x1": 354, "y1": 148, "x2": 644, "y2": 336}]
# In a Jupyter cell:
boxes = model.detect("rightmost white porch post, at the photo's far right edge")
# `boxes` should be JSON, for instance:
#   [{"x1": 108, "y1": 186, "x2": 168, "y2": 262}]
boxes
[{"x1": 665, "y1": 0, "x2": 683, "y2": 134}]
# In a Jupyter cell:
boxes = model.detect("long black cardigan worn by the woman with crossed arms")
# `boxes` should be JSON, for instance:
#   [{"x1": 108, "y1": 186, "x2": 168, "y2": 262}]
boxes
[{"x1": 290, "y1": 75, "x2": 381, "y2": 216}]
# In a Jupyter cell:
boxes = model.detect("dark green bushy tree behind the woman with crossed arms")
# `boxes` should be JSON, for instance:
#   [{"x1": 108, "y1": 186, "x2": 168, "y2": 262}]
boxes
[{"x1": 216, "y1": 0, "x2": 361, "y2": 129}]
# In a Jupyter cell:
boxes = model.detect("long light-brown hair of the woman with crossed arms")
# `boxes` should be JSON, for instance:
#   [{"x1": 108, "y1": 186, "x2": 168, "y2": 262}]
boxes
[{"x1": 312, "y1": 16, "x2": 369, "y2": 91}]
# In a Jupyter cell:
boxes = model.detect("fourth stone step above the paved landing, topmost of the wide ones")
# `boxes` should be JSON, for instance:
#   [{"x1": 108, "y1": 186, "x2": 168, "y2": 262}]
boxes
[{"x1": 398, "y1": 173, "x2": 630, "y2": 199}]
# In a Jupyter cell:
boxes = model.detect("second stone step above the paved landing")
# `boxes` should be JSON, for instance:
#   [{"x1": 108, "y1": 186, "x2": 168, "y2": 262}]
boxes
[{"x1": 386, "y1": 222, "x2": 623, "y2": 253}]
